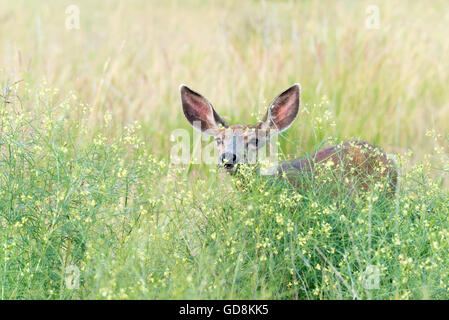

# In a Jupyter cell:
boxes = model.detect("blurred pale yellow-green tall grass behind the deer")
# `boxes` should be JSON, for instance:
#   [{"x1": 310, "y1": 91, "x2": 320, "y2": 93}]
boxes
[{"x1": 0, "y1": 0, "x2": 449, "y2": 164}]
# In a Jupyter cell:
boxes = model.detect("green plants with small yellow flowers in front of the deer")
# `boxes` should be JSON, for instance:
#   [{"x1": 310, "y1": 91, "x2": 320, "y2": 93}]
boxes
[{"x1": 0, "y1": 90, "x2": 449, "y2": 299}]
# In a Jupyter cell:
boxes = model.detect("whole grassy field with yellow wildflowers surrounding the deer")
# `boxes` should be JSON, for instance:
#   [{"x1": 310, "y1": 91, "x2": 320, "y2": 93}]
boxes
[{"x1": 0, "y1": 0, "x2": 449, "y2": 299}]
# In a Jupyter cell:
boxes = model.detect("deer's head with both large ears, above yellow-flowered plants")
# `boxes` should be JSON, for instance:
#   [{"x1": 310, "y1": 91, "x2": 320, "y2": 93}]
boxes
[{"x1": 180, "y1": 84, "x2": 301, "y2": 172}]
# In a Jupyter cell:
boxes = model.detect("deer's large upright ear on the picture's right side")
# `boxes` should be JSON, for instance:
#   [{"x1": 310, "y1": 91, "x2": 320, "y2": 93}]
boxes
[{"x1": 259, "y1": 83, "x2": 301, "y2": 133}]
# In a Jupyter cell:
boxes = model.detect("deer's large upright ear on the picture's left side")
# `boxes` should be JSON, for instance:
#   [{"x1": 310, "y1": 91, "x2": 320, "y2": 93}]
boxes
[{"x1": 179, "y1": 84, "x2": 229, "y2": 134}]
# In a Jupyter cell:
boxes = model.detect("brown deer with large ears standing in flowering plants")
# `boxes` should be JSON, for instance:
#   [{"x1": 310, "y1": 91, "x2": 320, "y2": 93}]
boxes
[{"x1": 179, "y1": 83, "x2": 398, "y2": 194}]
